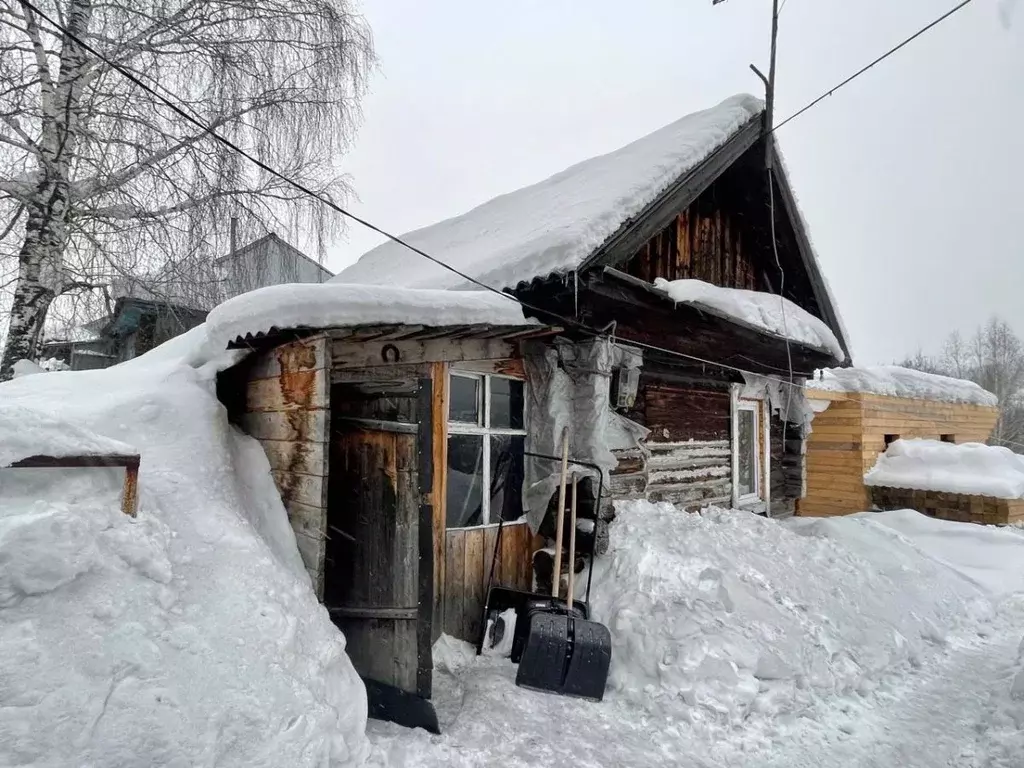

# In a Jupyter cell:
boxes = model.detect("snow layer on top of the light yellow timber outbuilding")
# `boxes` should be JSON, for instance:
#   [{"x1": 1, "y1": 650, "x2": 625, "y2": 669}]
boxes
[{"x1": 807, "y1": 366, "x2": 997, "y2": 406}]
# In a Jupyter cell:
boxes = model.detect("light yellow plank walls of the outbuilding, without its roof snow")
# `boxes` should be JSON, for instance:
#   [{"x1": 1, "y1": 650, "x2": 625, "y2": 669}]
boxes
[{"x1": 797, "y1": 391, "x2": 998, "y2": 517}]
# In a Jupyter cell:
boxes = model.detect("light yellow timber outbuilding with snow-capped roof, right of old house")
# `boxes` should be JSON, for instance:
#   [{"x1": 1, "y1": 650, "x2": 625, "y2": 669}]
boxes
[{"x1": 797, "y1": 366, "x2": 999, "y2": 516}]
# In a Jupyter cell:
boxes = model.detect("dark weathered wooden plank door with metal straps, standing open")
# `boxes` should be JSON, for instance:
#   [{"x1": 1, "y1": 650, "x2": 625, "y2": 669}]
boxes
[{"x1": 324, "y1": 379, "x2": 433, "y2": 698}]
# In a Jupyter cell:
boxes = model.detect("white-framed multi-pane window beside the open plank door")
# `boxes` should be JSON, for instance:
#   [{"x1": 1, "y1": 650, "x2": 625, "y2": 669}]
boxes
[{"x1": 445, "y1": 372, "x2": 526, "y2": 528}]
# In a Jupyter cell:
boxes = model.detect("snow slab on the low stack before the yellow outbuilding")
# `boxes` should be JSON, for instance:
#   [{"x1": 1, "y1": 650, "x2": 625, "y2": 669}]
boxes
[{"x1": 864, "y1": 439, "x2": 1024, "y2": 499}]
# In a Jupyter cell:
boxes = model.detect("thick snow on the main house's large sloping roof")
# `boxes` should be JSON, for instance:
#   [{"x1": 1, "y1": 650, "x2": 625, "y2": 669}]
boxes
[{"x1": 335, "y1": 95, "x2": 763, "y2": 288}]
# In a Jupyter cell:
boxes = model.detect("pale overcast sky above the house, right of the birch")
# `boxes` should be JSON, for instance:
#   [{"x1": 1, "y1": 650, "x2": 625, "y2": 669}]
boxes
[{"x1": 328, "y1": 0, "x2": 1024, "y2": 365}]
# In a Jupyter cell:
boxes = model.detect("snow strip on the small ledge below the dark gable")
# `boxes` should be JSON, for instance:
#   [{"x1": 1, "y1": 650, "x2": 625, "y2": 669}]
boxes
[{"x1": 654, "y1": 278, "x2": 846, "y2": 360}]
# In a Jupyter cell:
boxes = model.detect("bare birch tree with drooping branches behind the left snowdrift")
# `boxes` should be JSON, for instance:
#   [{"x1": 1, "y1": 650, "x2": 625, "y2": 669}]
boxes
[{"x1": 0, "y1": 0, "x2": 373, "y2": 380}]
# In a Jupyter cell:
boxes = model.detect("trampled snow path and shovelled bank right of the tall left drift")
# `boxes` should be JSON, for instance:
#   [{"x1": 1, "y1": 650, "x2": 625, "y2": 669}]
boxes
[{"x1": 369, "y1": 505, "x2": 1024, "y2": 768}]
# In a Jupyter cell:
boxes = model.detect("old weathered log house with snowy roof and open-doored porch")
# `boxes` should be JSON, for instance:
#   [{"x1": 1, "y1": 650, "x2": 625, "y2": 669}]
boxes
[{"x1": 216, "y1": 96, "x2": 847, "y2": 729}]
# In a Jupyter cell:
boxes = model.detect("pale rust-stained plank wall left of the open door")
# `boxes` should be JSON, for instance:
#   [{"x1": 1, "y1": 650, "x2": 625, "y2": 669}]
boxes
[{"x1": 241, "y1": 336, "x2": 330, "y2": 596}]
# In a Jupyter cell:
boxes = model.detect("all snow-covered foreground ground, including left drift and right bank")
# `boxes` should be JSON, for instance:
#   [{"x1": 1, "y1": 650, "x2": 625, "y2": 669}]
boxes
[{"x1": 0, "y1": 330, "x2": 1024, "y2": 768}]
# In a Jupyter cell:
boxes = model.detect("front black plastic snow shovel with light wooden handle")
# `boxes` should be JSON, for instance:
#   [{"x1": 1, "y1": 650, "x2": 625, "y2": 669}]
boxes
[{"x1": 515, "y1": 429, "x2": 611, "y2": 701}]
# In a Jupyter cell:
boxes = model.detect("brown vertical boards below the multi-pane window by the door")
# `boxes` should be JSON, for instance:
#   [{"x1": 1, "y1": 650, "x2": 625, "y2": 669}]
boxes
[{"x1": 444, "y1": 523, "x2": 543, "y2": 643}]
